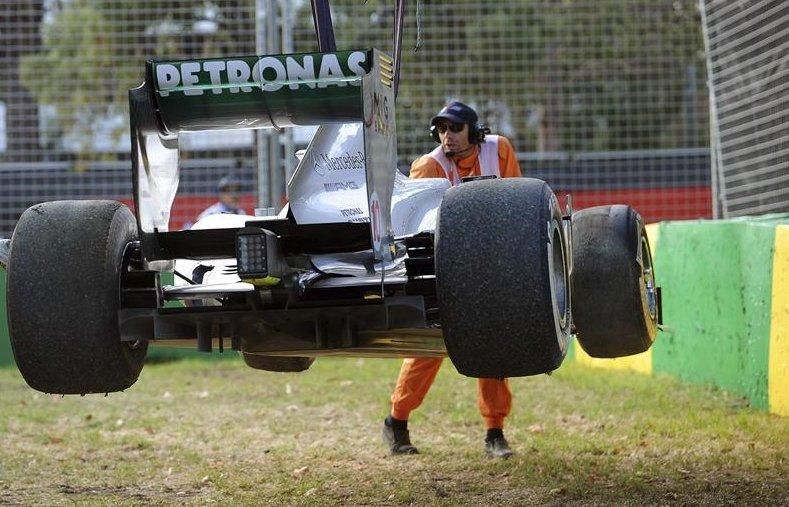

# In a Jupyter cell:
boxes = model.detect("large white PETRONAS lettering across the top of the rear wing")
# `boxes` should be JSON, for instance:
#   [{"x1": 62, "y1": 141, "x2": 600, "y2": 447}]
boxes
[{"x1": 155, "y1": 51, "x2": 367, "y2": 97}]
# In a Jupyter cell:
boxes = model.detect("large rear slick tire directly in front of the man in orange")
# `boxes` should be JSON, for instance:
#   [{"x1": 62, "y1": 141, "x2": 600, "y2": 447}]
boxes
[{"x1": 435, "y1": 178, "x2": 571, "y2": 378}]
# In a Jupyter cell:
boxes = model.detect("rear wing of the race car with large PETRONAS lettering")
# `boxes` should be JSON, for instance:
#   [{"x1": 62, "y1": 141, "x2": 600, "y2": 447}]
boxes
[{"x1": 129, "y1": 49, "x2": 397, "y2": 258}]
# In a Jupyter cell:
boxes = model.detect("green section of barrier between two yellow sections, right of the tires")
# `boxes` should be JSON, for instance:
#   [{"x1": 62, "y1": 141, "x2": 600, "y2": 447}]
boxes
[{"x1": 652, "y1": 222, "x2": 775, "y2": 409}]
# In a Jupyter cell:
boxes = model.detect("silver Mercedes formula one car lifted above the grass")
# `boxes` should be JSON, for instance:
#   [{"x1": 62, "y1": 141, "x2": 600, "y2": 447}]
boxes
[{"x1": 0, "y1": 2, "x2": 660, "y2": 394}]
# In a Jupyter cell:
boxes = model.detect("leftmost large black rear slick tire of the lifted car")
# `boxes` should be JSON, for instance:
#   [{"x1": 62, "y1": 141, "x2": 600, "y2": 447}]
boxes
[{"x1": 7, "y1": 201, "x2": 148, "y2": 394}]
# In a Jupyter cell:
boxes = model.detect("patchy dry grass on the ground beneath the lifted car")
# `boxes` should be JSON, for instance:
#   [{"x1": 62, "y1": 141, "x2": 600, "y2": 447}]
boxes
[{"x1": 0, "y1": 358, "x2": 789, "y2": 506}]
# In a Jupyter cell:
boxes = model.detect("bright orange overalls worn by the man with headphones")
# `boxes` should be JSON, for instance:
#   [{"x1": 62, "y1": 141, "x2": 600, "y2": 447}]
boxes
[{"x1": 391, "y1": 136, "x2": 521, "y2": 429}]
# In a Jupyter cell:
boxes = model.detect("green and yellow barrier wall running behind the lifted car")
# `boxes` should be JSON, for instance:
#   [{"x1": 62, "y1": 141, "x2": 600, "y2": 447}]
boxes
[{"x1": 0, "y1": 214, "x2": 789, "y2": 416}]
